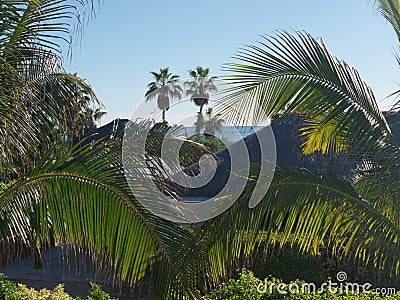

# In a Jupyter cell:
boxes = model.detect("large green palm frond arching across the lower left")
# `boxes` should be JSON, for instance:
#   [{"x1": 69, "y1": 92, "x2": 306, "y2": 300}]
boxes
[{"x1": 0, "y1": 135, "x2": 211, "y2": 299}]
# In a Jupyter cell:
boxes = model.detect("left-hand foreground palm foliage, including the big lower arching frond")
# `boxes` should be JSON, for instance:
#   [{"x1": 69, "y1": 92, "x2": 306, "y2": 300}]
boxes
[{"x1": 0, "y1": 0, "x2": 205, "y2": 299}]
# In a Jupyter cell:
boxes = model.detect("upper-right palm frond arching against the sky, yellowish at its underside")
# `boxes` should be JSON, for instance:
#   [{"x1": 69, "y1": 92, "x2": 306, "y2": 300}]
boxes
[{"x1": 220, "y1": 32, "x2": 393, "y2": 157}]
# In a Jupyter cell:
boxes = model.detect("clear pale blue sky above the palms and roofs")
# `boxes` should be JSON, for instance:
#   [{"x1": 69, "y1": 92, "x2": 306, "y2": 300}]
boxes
[{"x1": 66, "y1": 0, "x2": 400, "y2": 124}]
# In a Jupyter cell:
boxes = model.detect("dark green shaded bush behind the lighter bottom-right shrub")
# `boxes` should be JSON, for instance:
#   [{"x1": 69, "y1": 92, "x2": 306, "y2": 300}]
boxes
[{"x1": 244, "y1": 236, "x2": 400, "y2": 290}]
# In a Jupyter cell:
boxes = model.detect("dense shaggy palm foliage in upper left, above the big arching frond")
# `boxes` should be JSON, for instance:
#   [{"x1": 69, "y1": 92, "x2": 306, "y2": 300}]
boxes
[{"x1": 0, "y1": 0, "x2": 101, "y2": 183}]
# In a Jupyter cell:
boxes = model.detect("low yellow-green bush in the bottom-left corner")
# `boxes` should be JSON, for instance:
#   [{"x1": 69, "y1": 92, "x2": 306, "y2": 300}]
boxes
[{"x1": 0, "y1": 274, "x2": 113, "y2": 300}]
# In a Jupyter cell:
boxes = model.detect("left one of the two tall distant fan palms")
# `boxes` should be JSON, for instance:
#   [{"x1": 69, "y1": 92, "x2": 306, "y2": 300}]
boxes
[{"x1": 145, "y1": 68, "x2": 182, "y2": 122}]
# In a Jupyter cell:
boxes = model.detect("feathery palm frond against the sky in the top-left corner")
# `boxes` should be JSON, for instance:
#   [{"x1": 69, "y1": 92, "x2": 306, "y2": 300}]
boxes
[{"x1": 0, "y1": 0, "x2": 99, "y2": 58}]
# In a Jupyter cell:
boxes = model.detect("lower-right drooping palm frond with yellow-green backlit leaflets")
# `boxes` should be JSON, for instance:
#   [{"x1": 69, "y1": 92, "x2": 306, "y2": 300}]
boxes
[{"x1": 200, "y1": 167, "x2": 400, "y2": 282}]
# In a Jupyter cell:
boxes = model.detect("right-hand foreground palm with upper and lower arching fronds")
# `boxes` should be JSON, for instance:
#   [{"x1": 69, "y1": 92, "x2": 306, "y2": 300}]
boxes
[{"x1": 202, "y1": 0, "x2": 400, "y2": 277}]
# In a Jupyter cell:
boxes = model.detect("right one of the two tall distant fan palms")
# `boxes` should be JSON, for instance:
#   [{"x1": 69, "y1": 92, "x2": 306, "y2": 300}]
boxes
[{"x1": 185, "y1": 66, "x2": 218, "y2": 114}]
